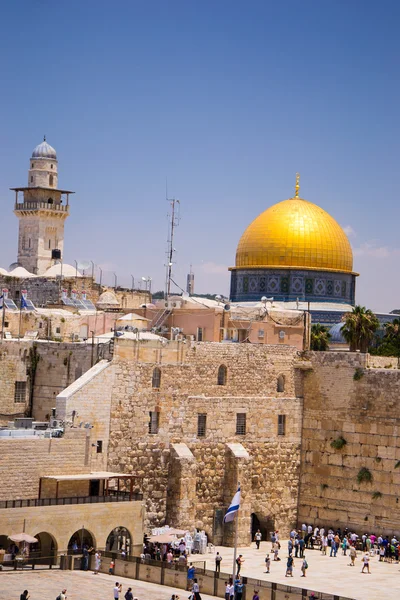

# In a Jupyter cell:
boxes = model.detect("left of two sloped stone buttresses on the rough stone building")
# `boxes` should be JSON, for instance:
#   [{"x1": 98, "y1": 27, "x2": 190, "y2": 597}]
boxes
[{"x1": 166, "y1": 444, "x2": 196, "y2": 531}]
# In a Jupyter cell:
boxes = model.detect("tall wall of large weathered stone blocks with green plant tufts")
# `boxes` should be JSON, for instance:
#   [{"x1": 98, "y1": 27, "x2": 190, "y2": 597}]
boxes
[{"x1": 299, "y1": 352, "x2": 400, "y2": 533}]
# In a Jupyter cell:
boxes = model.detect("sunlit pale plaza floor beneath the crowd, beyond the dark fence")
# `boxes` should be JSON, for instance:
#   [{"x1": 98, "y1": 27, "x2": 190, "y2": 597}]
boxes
[{"x1": 192, "y1": 541, "x2": 400, "y2": 600}]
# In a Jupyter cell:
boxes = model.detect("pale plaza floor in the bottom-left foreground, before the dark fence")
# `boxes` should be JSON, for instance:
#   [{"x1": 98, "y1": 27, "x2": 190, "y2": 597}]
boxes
[{"x1": 0, "y1": 570, "x2": 217, "y2": 600}]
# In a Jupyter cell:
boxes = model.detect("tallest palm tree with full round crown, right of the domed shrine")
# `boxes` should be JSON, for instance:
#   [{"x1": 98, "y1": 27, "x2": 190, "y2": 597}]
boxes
[{"x1": 342, "y1": 306, "x2": 379, "y2": 352}]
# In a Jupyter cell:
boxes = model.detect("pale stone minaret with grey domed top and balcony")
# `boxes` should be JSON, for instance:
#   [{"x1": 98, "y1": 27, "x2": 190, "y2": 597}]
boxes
[{"x1": 11, "y1": 138, "x2": 74, "y2": 275}]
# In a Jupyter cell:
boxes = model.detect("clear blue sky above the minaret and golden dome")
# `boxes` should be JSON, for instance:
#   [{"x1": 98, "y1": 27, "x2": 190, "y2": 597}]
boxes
[{"x1": 0, "y1": 0, "x2": 400, "y2": 310}]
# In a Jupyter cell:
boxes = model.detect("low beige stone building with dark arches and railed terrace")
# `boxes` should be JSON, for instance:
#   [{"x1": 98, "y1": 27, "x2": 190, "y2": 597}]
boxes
[{"x1": 0, "y1": 428, "x2": 144, "y2": 562}]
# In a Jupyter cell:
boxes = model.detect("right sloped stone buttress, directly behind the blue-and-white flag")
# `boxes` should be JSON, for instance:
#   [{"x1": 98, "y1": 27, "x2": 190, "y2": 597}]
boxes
[{"x1": 223, "y1": 444, "x2": 252, "y2": 546}]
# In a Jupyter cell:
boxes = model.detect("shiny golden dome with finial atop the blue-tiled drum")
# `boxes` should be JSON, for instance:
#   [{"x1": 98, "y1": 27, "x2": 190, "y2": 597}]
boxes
[{"x1": 236, "y1": 195, "x2": 353, "y2": 273}]
